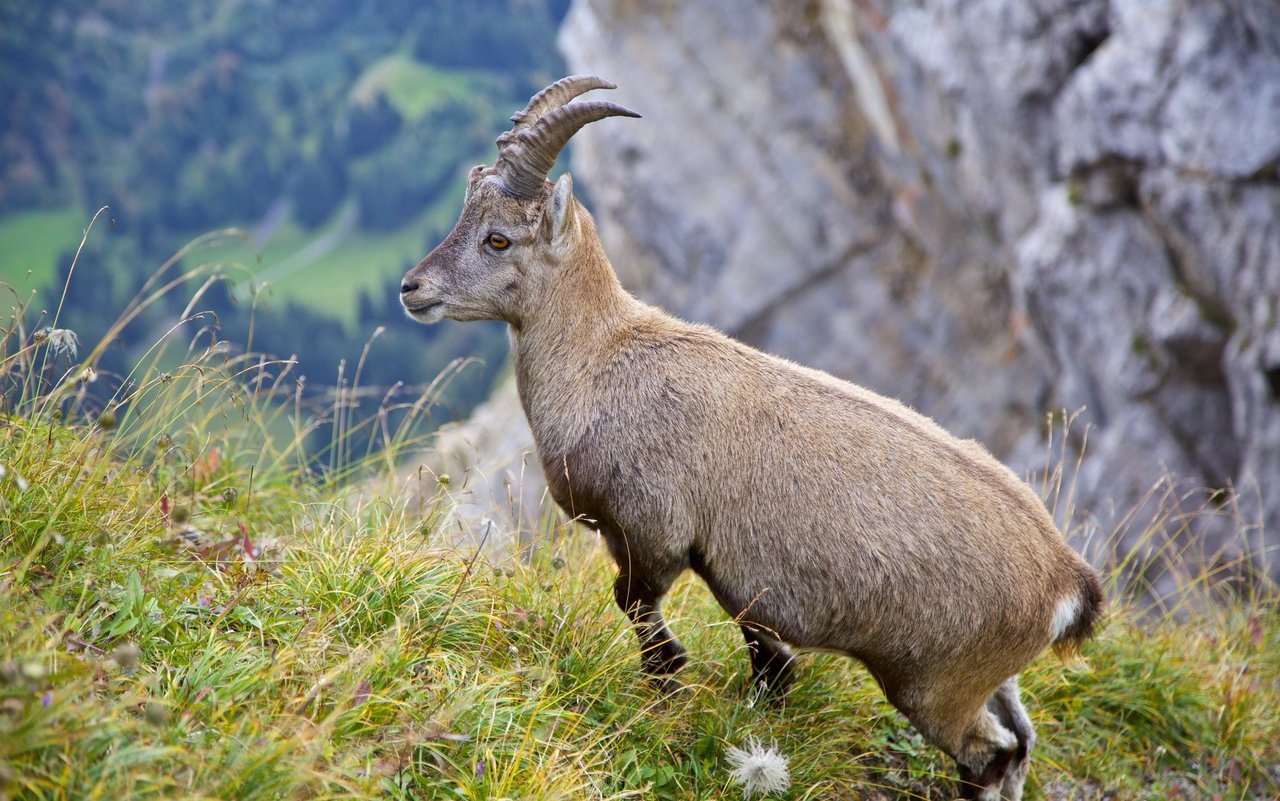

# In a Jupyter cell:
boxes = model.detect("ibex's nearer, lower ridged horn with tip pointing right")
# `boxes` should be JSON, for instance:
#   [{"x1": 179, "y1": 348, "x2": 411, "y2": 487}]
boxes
[{"x1": 494, "y1": 99, "x2": 640, "y2": 197}]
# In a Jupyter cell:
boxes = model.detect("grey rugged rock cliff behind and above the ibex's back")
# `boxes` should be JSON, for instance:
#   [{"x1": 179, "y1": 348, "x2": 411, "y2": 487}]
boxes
[{"x1": 414, "y1": 0, "x2": 1280, "y2": 586}]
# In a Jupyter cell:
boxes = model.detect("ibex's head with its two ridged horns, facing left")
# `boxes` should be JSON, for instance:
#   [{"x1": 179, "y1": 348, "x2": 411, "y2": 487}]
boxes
[{"x1": 401, "y1": 75, "x2": 640, "y2": 326}]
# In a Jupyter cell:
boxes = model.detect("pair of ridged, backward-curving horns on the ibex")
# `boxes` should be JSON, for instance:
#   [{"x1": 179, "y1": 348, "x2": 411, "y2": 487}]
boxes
[{"x1": 494, "y1": 75, "x2": 640, "y2": 197}]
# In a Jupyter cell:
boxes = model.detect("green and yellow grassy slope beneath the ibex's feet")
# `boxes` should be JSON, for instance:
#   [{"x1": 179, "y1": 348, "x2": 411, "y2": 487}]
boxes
[{"x1": 0, "y1": 349, "x2": 1280, "y2": 798}]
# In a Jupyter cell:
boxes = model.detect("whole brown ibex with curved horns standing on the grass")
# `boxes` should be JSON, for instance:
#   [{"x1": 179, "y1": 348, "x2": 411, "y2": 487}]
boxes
[{"x1": 401, "y1": 75, "x2": 1103, "y2": 798}]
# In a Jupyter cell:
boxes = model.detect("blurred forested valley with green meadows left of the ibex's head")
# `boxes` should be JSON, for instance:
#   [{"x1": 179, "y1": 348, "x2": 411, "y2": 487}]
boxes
[{"x1": 0, "y1": 0, "x2": 567, "y2": 429}]
